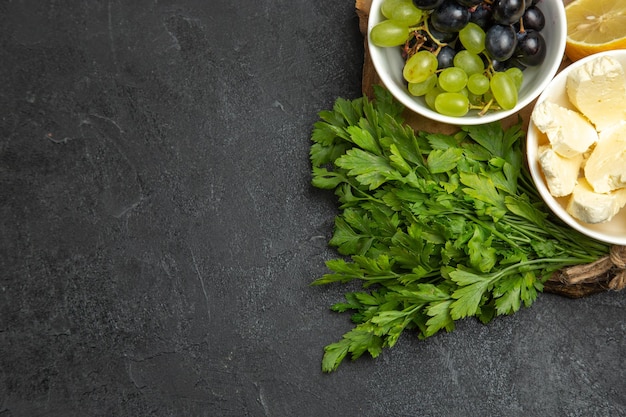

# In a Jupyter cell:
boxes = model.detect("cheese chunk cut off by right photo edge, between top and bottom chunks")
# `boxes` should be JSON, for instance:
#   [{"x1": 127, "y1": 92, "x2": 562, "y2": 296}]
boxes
[{"x1": 585, "y1": 123, "x2": 626, "y2": 193}]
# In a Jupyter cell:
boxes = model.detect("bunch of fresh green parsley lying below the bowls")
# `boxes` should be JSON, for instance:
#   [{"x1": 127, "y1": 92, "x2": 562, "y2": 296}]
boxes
[{"x1": 310, "y1": 86, "x2": 609, "y2": 372}]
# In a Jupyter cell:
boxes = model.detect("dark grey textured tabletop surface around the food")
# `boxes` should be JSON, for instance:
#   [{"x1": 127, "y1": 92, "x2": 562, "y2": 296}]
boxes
[{"x1": 0, "y1": 0, "x2": 626, "y2": 417}]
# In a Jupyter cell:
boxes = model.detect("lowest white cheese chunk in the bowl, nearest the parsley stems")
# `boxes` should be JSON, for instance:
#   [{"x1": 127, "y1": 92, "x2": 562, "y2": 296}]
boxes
[{"x1": 566, "y1": 178, "x2": 626, "y2": 224}]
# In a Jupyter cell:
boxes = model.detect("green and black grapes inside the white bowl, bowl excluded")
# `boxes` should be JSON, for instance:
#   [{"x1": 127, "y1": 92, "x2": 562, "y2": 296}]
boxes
[{"x1": 370, "y1": 0, "x2": 546, "y2": 117}]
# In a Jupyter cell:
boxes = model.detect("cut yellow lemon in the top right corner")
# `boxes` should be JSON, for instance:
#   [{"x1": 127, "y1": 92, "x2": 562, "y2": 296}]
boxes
[{"x1": 565, "y1": 0, "x2": 626, "y2": 61}]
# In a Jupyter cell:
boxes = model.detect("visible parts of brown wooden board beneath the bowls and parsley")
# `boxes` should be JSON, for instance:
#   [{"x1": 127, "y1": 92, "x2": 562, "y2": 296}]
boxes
[{"x1": 356, "y1": 0, "x2": 626, "y2": 298}]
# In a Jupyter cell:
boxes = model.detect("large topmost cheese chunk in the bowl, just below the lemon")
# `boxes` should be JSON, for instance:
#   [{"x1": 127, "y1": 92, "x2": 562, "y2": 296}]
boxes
[{"x1": 565, "y1": 56, "x2": 626, "y2": 131}]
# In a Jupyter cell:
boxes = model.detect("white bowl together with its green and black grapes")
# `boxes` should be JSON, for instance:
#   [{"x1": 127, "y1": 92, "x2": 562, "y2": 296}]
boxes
[{"x1": 367, "y1": 0, "x2": 567, "y2": 125}]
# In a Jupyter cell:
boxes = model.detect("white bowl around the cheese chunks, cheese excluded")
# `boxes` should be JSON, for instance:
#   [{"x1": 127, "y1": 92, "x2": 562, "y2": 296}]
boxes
[{"x1": 526, "y1": 50, "x2": 626, "y2": 245}]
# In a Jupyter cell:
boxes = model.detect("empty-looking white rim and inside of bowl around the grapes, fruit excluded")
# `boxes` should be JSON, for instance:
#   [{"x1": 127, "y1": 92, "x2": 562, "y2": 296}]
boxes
[{"x1": 367, "y1": 0, "x2": 567, "y2": 125}]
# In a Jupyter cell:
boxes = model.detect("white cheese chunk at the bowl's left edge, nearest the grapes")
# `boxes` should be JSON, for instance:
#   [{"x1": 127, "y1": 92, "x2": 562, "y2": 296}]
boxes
[{"x1": 531, "y1": 101, "x2": 598, "y2": 158}]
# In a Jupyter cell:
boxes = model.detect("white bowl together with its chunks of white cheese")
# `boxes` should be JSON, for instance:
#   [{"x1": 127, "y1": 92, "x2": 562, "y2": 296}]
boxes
[{"x1": 526, "y1": 50, "x2": 626, "y2": 245}]
